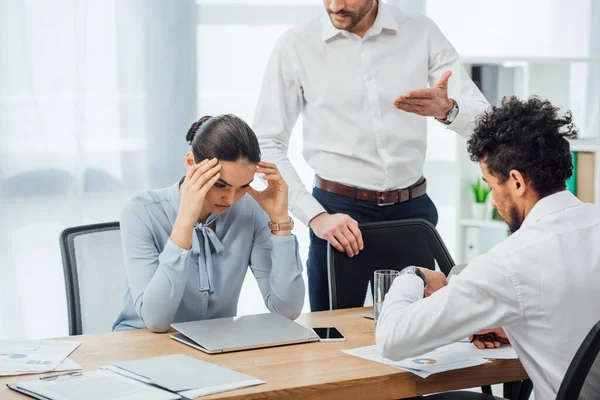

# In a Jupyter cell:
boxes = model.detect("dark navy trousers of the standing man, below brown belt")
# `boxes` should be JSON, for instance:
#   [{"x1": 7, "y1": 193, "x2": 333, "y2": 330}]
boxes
[{"x1": 306, "y1": 187, "x2": 438, "y2": 311}]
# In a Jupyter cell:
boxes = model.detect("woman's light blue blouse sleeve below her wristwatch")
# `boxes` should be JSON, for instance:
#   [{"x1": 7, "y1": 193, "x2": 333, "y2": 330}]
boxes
[{"x1": 249, "y1": 206, "x2": 305, "y2": 319}]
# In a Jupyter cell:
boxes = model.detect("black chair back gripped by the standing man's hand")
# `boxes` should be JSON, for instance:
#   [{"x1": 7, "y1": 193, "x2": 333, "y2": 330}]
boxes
[{"x1": 327, "y1": 219, "x2": 454, "y2": 310}]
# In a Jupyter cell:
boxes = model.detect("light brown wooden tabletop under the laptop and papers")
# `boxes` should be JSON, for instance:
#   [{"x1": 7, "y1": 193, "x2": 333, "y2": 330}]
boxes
[{"x1": 0, "y1": 308, "x2": 527, "y2": 399}]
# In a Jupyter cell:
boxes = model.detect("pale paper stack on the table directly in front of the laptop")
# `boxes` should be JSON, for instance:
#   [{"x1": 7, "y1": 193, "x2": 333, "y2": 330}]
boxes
[{"x1": 102, "y1": 354, "x2": 265, "y2": 398}]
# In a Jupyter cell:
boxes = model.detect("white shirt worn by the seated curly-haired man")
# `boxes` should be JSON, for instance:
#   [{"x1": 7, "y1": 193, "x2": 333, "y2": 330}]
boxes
[{"x1": 377, "y1": 191, "x2": 600, "y2": 400}]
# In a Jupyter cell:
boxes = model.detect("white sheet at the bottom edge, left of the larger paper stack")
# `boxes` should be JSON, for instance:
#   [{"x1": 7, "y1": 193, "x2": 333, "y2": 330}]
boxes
[{"x1": 16, "y1": 371, "x2": 181, "y2": 400}]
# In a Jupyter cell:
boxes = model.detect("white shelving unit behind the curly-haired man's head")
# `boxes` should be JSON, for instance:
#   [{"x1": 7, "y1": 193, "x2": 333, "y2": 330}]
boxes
[{"x1": 456, "y1": 57, "x2": 600, "y2": 263}]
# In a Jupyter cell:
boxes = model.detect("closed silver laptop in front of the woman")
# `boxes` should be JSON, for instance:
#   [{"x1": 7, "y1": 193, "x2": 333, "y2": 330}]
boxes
[{"x1": 171, "y1": 313, "x2": 319, "y2": 354}]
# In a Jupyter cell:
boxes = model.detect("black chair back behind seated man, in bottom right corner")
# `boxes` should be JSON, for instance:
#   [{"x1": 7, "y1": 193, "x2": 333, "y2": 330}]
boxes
[{"x1": 556, "y1": 322, "x2": 600, "y2": 400}]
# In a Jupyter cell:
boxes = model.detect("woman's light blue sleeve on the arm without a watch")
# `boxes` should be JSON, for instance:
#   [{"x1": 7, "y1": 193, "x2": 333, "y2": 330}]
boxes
[{"x1": 121, "y1": 200, "x2": 189, "y2": 332}]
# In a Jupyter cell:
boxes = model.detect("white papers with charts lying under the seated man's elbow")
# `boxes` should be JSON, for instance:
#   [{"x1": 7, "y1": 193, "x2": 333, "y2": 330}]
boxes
[{"x1": 343, "y1": 342, "x2": 517, "y2": 378}]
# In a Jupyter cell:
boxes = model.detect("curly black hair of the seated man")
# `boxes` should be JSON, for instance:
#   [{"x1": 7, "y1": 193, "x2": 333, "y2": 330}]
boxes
[{"x1": 467, "y1": 96, "x2": 577, "y2": 198}]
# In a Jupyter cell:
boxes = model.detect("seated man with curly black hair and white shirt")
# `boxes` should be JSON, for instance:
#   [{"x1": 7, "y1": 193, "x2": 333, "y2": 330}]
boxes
[{"x1": 377, "y1": 97, "x2": 600, "y2": 399}]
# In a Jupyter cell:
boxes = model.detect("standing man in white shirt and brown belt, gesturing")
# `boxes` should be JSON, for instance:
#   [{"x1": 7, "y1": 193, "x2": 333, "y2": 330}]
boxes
[{"x1": 254, "y1": 0, "x2": 488, "y2": 311}]
